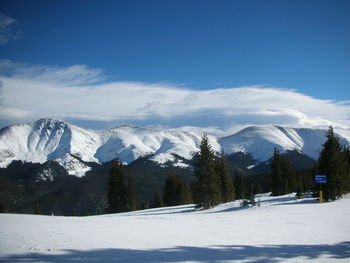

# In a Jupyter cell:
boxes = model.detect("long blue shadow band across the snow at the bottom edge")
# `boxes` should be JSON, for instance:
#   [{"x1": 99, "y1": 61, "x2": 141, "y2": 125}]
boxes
[{"x1": 0, "y1": 242, "x2": 350, "y2": 263}]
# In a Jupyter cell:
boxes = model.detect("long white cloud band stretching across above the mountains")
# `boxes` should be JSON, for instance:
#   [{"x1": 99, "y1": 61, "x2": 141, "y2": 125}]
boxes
[{"x1": 0, "y1": 61, "x2": 350, "y2": 133}]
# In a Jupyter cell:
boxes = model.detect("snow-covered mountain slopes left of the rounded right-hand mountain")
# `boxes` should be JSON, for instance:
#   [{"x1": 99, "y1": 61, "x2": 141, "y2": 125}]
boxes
[{"x1": 0, "y1": 119, "x2": 220, "y2": 176}]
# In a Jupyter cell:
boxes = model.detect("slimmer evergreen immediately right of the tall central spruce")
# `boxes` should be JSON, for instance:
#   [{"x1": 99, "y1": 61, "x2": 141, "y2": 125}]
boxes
[{"x1": 215, "y1": 152, "x2": 235, "y2": 203}]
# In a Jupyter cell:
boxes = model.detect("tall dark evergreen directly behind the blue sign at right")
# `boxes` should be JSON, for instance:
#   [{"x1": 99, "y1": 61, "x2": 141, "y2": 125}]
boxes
[{"x1": 317, "y1": 127, "x2": 346, "y2": 200}]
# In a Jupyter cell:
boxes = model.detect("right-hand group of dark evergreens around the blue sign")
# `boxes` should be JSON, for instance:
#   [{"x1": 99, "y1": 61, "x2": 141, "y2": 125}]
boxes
[{"x1": 271, "y1": 127, "x2": 350, "y2": 201}]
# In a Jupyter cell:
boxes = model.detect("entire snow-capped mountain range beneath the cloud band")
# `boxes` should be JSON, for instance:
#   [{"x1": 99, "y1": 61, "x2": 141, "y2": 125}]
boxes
[{"x1": 0, "y1": 119, "x2": 349, "y2": 176}]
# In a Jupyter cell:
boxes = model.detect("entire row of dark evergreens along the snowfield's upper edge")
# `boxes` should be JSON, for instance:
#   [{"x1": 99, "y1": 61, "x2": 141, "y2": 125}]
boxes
[{"x1": 108, "y1": 127, "x2": 350, "y2": 212}]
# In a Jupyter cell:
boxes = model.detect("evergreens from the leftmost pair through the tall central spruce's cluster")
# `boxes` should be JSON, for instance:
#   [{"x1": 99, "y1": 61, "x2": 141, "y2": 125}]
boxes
[{"x1": 107, "y1": 134, "x2": 243, "y2": 213}]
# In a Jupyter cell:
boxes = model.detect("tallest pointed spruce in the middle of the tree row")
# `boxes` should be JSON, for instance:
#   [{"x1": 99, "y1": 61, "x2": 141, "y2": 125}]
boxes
[{"x1": 193, "y1": 134, "x2": 221, "y2": 209}]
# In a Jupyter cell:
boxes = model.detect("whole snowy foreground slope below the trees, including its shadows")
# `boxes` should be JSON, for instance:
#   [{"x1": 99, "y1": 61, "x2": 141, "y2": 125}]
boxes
[{"x1": 0, "y1": 195, "x2": 350, "y2": 263}]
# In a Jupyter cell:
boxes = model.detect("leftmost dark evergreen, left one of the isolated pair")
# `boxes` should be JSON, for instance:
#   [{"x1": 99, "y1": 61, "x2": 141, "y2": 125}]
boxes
[{"x1": 107, "y1": 161, "x2": 127, "y2": 213}]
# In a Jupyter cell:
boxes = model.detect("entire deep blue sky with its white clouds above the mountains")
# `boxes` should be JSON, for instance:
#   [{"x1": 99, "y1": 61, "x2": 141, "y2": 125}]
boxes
[{"x1": 0, "y1": 0, "x2": 350, "y2": 132}]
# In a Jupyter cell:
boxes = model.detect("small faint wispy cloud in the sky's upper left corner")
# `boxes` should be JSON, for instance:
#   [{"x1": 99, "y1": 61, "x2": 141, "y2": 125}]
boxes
[{"x1": 0, "y1": 13, "x2": 22, "y2": 45}]
